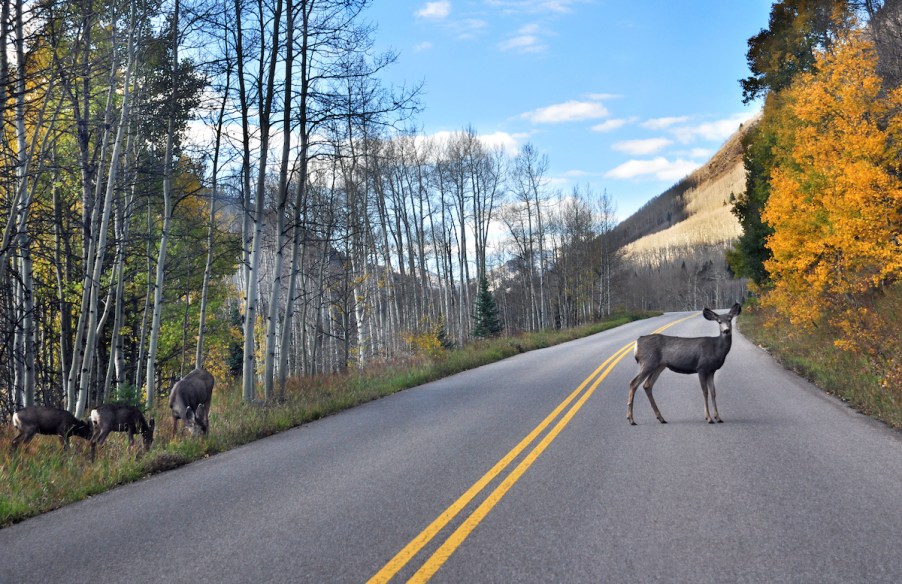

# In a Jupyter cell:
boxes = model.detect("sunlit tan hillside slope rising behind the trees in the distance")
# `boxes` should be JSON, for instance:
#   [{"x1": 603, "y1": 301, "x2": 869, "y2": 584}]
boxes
[{"x1": 614, "y1": 114, "x2": 756, "y2": 256}]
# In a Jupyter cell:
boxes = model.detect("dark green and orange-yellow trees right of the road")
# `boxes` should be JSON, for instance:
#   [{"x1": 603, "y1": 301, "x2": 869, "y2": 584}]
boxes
[{"x1": 729, "y1": 0, "x2": 902, "y2": 396}]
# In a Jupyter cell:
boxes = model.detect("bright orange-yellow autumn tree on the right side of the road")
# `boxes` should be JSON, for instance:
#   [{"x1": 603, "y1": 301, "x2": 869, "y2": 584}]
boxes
[{"x1": 762, "y1": 31, "x2": 902, "y2": 388}]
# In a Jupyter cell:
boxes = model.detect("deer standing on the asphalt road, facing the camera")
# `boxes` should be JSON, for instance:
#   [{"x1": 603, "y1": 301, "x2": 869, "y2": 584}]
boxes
[{"x1": 626, "y1": 303, "x2": 742, "y2": 426}]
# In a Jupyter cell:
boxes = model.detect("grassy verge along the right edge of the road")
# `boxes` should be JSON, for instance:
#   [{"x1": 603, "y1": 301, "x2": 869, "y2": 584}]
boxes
[{"x1": 739, "y1": 307, "x2": 902, "y2": 429}]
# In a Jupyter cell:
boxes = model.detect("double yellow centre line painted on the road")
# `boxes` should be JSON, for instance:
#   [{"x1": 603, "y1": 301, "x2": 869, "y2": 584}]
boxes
[{"x1": 368, "y1": 313, "x2": 698, "y2": 584}]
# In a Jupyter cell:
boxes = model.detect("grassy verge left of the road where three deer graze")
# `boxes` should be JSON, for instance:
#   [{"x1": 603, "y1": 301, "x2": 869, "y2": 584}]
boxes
[{"x1": 0, "y1": 313, "x2": 659, "y2": 527}]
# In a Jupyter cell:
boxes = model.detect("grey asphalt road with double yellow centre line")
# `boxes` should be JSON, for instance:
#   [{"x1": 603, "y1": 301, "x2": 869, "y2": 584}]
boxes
[{"x1": 0, "y1": 313, "x2": 902, "y2": 584}]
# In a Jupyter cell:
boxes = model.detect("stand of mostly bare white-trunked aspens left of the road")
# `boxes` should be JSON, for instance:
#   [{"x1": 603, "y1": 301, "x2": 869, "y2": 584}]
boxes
[{"x1": 0, "y1": 0, "x2": 618, "y2": 417}]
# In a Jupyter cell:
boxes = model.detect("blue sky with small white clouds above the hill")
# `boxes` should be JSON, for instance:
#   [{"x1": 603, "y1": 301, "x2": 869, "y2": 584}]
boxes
[{"x1": 367, "y1": 0, "x2": 771, "y2": 218}]
